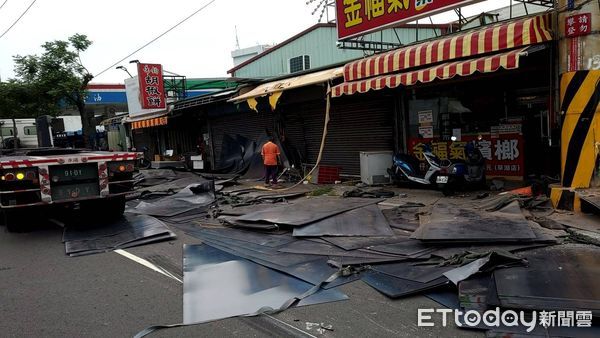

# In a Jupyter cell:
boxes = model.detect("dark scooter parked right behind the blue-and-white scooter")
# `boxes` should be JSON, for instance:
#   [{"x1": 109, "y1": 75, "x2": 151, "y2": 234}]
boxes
[{"x1": 437, "y1": 136, "x2": 486, "y2": 196}]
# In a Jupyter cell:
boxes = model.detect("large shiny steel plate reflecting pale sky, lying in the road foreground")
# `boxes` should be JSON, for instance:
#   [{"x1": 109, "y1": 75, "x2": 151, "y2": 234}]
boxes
[{"x1": 183, "y1": 244, "x2": 348, "y2": 324}]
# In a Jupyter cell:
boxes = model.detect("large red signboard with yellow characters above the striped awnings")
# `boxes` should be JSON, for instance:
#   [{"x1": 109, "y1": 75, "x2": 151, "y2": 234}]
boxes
[{"x1": 335, "y1": 0, "x2": 483, "y2": 40}]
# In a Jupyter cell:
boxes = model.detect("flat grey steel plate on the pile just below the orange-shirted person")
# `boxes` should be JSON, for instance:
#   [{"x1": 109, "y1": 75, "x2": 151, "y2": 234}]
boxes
[{"x1": 237, "y1": 197, "x2": 381, "y2": 226}]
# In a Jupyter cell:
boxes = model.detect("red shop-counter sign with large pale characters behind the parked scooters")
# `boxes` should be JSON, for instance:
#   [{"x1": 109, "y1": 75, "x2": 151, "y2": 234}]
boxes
[{"x1": 409, "y1": 133, "x2": 525, "y2": 177}]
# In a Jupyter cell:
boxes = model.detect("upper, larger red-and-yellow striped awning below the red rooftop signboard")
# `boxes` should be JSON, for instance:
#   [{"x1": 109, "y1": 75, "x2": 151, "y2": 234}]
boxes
[{"x1": 344, "y1": 14, "x2": 552, "y2": 82}]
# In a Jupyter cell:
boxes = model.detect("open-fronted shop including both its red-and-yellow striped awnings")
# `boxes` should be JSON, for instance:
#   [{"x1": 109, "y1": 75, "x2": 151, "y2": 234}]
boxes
[{"x1": 332, "y1": 15, "x2": 560, "y2": 179}]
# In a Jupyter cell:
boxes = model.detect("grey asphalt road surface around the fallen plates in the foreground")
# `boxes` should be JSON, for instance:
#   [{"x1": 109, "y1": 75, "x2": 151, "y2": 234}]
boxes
[{"x1": 0, "y1": 197, "x2": 483, "y2": 337}]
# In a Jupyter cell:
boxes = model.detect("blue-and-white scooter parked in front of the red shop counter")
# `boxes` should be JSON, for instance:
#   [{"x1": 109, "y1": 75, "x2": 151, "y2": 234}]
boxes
[{"x1": 387, "y1": 145, "x2": 450, "y2": 187}]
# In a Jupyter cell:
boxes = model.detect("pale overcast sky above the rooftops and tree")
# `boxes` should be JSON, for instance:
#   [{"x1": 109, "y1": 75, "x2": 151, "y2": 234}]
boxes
[{"x1": 0, "y1": 0, "x2": 509, "y2": 83}]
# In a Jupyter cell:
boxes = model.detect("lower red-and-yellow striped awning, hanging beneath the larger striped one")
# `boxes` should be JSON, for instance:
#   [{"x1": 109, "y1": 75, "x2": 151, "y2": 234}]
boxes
[{"x1": 332, "y1": 47, "x2": 528, "y2": 97}]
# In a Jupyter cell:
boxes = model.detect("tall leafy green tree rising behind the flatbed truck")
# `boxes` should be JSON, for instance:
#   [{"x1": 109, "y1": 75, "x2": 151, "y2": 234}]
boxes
[{"x1": 14, "y1": 34, "x2": 96, "y2": 147}]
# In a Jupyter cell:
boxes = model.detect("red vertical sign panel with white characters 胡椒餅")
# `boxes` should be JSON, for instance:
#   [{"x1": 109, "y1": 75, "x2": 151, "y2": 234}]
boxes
[{"x1": 138, "y1": 63, "x2": 166, "y2": 109}]
